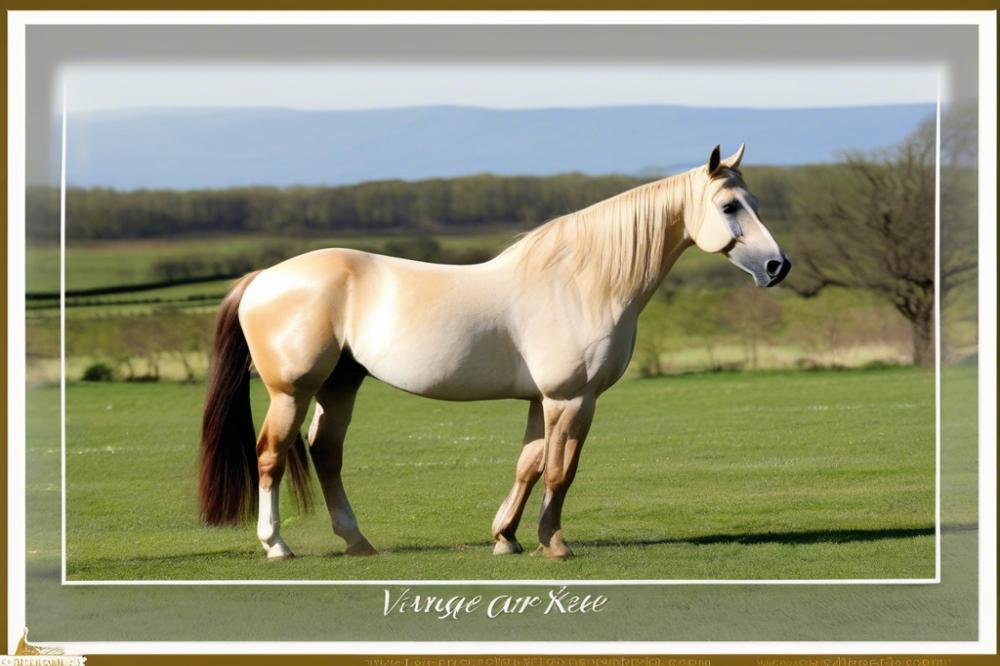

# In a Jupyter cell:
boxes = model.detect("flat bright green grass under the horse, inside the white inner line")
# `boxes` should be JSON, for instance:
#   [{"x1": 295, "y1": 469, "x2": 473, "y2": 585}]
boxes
[{"x1": 56, "y1": 369, "x2": 934, "y2": 580}]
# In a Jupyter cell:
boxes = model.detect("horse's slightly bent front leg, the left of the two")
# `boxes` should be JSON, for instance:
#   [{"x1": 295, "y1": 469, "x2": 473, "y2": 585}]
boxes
[{"x1": 492, "y1": 402, "x2": 545, "y2": 555}]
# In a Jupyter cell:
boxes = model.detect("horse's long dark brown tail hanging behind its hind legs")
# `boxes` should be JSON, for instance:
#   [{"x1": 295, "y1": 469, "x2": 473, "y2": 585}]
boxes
[{"x1": 198, "y1": 271, "x2": 311, "y2": 525}]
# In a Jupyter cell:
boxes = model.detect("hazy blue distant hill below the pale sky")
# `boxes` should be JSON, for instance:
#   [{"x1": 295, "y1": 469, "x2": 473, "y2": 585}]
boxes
[{"x1": 67, "y1": 104, "x2": 934, "y2": 189}]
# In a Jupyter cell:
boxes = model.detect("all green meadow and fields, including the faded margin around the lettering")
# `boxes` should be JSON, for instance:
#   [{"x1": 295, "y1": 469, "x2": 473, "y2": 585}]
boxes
[{"x1": 21, "y1": 228, "x2": 977, "y2": 640}]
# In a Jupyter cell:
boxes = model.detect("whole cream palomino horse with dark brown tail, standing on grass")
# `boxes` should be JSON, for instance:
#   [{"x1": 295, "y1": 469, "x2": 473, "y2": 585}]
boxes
[{"x1": 200, "y1": 146, "x2": 790, "y2": 558}]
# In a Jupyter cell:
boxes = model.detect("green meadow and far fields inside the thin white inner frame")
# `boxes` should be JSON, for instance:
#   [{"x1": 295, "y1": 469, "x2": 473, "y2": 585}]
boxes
[{"x1": 19, "y1": 227, "x2": 960, "y2": 580}]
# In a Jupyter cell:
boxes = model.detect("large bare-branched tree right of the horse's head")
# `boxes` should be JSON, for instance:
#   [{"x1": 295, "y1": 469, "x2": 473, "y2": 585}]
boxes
[{"x1": 788, "y1": 107, "x2": 976, "y2": 367}]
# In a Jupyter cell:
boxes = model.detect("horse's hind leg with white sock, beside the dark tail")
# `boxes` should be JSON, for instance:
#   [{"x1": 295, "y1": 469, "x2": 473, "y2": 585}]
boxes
[{"x1": 257, "y1": 391, "x2": 312, "y2": 559}]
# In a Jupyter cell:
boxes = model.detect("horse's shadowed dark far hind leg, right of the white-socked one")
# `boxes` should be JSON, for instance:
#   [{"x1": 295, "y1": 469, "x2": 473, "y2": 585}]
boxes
[{"x1": 309, "y1": 353, "x2": 376, "y2": 555}]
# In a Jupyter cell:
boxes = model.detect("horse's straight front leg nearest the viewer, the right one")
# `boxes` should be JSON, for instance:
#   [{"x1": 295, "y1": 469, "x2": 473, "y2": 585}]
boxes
[{"x1": 538, "y1": 396, "x2": 595, "y2": 559}]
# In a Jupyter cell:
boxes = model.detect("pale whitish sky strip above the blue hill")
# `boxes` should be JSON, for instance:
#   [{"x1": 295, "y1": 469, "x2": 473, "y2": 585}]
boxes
[{"x1": 60, "y1": 62, "x2": 938, "y2": 112}]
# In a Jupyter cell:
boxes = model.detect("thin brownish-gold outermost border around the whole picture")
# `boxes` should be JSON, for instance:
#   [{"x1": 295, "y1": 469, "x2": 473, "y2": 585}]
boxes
[{"x1": 0, "y1": 6, "x2": 1000, "y2": 666}]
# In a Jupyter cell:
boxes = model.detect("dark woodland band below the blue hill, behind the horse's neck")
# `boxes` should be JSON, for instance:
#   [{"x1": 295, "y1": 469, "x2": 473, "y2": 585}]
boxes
[{"x1": 26, "y1": 168, "x2": 790, "y2": 240}]
